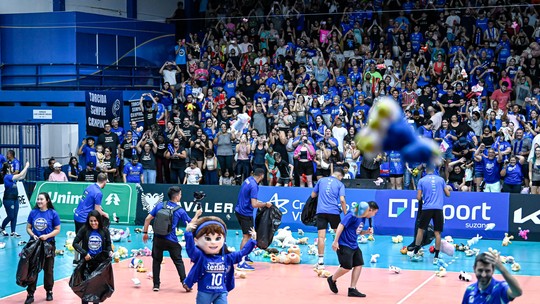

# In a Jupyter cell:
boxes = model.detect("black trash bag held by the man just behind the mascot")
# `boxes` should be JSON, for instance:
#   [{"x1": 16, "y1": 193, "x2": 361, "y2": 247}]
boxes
[{"x1": 255, "y1": 205, "x2": 282, "y2": 249}]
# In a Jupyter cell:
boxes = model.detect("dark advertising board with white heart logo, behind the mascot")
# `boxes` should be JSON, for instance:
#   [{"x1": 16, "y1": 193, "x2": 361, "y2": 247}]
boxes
[{"x1": 136, "y1": 184, "x2": 240, "y2": 229}]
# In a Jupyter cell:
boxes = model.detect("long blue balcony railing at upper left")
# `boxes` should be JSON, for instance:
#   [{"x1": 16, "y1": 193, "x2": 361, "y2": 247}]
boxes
[{"x1": 0, "y1": 63, "x2": 161, "y2": 90}]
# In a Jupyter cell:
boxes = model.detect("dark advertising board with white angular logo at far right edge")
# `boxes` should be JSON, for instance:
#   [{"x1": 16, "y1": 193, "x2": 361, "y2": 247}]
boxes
[{"x1": 508, "y1": 194, "x2": 540, "y2": 242}]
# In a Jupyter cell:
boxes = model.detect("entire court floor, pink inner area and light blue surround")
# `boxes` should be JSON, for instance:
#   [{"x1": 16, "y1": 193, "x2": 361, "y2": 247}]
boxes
[{"x1": 0, "y1": 223, "x2": 540, "y2": 304}]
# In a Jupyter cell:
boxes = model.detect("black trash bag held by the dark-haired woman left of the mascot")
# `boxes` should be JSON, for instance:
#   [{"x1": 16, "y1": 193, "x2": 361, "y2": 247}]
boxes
[{"x1": 69, "y1": 254, "x2": 114, "y2": 302}]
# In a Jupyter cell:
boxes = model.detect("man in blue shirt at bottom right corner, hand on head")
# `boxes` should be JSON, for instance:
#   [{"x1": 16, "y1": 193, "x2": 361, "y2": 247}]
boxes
[{"x1": 461, "y1": 252, "x2": 523, "y2": 304}]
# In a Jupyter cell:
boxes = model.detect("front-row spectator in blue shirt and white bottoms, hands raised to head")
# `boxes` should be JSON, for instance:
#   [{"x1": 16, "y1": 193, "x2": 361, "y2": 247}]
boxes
[{"x1": 474, "y1": 143, "x2": 503, "y2": 192}]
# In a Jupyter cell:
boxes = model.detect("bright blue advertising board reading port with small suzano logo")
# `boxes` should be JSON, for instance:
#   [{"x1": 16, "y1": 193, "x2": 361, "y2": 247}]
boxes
[{"x1": 375, "y1": 190, "x2": 509, "y2": 239}]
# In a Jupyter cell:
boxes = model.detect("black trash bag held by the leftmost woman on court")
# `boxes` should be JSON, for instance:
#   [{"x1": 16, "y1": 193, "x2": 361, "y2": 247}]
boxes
[{"x1": 16, "y1": 239, "x2": 44, "y2": 287}]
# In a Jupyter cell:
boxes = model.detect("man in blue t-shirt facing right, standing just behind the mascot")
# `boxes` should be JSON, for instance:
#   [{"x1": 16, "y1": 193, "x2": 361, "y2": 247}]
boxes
[{"x1": 234, "y1": 168, "x2": 272, "y2": 270}]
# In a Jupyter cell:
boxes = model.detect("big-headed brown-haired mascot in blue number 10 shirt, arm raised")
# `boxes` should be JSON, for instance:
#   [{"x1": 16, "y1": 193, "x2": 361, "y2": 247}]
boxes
[{"x1": 185, "y1": 216, "x2": 257, "y2": 304}]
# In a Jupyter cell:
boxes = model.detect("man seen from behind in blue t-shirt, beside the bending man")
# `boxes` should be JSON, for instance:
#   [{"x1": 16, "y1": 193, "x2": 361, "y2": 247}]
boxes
[{"x1": 311, "y1": 168, "x2": 347, "y2": 270}]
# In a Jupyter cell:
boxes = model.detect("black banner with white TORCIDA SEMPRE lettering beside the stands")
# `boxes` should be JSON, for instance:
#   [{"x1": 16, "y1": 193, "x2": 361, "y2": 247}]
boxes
[{"x1": 86, "y1": 91, "x2": 124, "y2": 136}]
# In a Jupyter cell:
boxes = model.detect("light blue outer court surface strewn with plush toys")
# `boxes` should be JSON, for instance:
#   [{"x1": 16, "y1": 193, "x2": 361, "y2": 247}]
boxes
[{"x1": 0, "y1": 223, "x2": 540, "y2": 303}]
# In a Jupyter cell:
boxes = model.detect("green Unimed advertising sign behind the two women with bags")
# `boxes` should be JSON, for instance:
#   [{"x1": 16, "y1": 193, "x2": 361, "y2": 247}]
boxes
[{"x1": 30, "y1": 182, "x2": 137, "y2": 224}]
